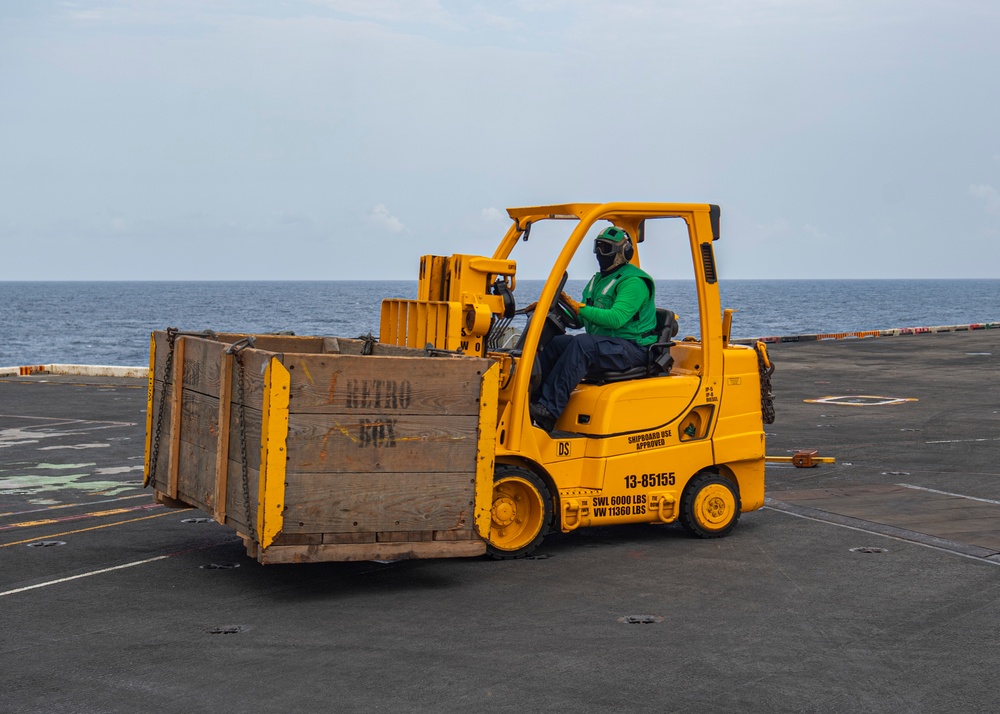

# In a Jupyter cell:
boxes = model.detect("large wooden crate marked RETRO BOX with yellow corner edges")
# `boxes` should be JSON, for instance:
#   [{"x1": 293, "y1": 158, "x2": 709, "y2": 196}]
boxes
[{"x1": 146, "y1": 331, "x2": 497, "y2": 563}]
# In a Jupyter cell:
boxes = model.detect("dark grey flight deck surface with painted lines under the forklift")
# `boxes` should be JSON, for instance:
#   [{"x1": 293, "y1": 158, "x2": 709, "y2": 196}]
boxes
[{"x1": 0, "y1": 330, "x2": 1000, "y2": 712}]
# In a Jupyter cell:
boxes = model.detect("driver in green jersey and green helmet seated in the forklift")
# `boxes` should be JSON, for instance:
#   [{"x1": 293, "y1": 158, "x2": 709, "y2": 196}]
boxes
[{"x1": 529, "y1": 226, "x2": 656, "y2": 431}]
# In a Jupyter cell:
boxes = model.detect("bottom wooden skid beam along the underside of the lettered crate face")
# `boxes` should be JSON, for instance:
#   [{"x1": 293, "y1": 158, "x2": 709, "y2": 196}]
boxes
[{"x1": 260, "y1": 540, "x2": 486, "y2": 565}]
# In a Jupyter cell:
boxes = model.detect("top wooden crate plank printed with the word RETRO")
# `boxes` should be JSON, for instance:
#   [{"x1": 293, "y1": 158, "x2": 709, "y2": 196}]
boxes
[{"x1": 285, "y1": 354, "x2": 491, "y2": 415}]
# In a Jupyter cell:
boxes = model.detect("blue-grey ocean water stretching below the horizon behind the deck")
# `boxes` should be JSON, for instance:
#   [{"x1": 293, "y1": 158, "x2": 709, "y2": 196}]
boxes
[{"x1": 0, "y1": 280, "x2": 1000, "y2": 367}]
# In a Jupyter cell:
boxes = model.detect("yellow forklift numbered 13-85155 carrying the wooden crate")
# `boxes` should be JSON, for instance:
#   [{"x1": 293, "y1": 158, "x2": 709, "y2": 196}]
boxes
[{"x1": 379, "y1": 203, "x2": 773, "y2": 559}]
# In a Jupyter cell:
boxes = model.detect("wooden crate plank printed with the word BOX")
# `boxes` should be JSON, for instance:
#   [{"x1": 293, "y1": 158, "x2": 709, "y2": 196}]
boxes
[{"x1": 288, "y1": 412, "x2": 478, "y2": 474}]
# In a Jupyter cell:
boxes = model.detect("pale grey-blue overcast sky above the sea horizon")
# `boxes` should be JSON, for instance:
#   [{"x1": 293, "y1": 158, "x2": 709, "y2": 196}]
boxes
[{"x1": 0, "y1": 0, "x2": 1000, "y2": 280}]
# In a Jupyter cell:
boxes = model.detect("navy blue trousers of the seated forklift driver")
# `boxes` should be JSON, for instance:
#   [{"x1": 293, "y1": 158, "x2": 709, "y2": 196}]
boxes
[{"x1": 538, "y1": 334, "x2": 649, "y2": 417}]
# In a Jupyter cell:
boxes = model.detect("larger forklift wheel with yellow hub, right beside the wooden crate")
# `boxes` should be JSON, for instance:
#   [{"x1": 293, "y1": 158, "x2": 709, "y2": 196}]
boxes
[{"x1": 486, "y1": 465, "x2": 552, "y2": 560}]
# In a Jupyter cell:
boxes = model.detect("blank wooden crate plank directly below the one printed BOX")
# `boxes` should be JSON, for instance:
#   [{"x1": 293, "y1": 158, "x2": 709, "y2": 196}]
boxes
[{"x1": 284, "y1": 472, "x2": 475, "y2": 533}]
